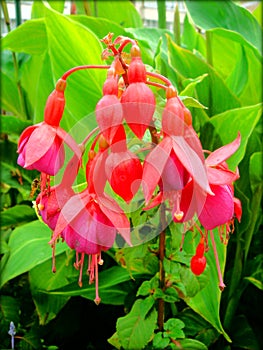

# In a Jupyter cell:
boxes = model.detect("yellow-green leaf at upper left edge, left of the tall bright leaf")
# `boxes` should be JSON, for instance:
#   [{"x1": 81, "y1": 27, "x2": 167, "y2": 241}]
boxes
[{"x1": 2, "y1": 19, "x2": 47, "y2": 55}]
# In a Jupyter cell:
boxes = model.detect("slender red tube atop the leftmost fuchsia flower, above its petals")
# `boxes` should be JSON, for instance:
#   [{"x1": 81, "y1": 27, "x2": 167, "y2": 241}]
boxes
[{"x1": 44, "y1": 79, "x2": 66, "y2": 126}]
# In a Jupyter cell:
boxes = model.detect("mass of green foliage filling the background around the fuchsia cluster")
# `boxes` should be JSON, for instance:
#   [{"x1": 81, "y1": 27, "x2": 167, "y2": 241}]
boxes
[{"x1": 0, "y1": 1, "x2": 263, "y2": 350}]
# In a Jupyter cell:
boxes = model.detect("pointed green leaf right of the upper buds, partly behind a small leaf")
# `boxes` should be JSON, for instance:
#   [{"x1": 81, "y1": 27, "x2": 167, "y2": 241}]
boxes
[{"x1": 168, "y1": 39, "x2": 240, "y2": 115}]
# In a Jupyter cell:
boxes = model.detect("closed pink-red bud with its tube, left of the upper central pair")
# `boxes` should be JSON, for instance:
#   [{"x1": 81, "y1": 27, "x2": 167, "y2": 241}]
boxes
[{"x1": 96, "y1": 69, "x2": 123, "y2": 144}]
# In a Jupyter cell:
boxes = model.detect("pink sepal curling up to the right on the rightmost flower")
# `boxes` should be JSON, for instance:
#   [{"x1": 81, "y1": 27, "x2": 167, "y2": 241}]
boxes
[{"x1": 206, "y1": 133, "x2": 241, "y2": 166}]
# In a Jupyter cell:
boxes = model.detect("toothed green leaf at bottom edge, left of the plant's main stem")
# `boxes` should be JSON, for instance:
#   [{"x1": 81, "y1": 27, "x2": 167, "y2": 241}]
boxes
[{"x1": 117, "y1": 300, "x2": 157, "y2": 350}]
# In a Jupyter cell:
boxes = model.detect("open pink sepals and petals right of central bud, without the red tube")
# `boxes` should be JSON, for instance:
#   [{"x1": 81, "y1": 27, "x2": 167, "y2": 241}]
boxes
[{"x1": 142, "y1": 136, "x2": 212, "y2": 213}]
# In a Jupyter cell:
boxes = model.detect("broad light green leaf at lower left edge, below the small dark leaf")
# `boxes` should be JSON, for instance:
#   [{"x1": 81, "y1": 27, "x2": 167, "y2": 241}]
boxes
[{"x1": 1, "y1": 220, "x2": 68, "y2": 286}]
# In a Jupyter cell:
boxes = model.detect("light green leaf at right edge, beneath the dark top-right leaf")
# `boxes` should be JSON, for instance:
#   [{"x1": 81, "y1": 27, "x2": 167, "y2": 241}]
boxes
[{"x1": 209, "y1": 28, "x2": 262, "y2": 105}]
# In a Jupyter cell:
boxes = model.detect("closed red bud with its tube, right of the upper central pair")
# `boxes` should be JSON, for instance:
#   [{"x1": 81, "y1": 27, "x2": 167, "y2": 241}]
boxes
[{"x1": 121, "y1": 45, "x2": 155, "y2": 139}]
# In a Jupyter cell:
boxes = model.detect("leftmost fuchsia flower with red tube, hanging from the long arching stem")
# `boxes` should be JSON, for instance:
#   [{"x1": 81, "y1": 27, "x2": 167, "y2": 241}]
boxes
[{"x1": 17, "y1": 80, "x2": 81, "y2": 175}]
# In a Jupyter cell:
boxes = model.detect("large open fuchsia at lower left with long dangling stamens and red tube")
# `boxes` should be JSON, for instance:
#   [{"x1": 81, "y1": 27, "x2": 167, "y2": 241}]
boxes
[{"x1": 50, "y1": 151, "x2": 131, "y2": 304}]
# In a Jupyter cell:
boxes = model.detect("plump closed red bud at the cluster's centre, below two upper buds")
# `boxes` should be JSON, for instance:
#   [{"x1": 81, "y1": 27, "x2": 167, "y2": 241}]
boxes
[{"x1": 105, "y1": 150, "x2": 142, "y2": 203}]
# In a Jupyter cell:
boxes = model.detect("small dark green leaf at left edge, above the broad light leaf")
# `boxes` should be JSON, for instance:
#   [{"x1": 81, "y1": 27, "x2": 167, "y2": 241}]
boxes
[{"x1": 1, "y1": 205, "x2": 36, "y2": 227}]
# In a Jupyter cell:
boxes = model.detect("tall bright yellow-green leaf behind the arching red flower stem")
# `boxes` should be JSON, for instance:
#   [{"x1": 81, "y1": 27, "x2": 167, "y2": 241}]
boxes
[{"x1": 45, "y1": 5, "x2": 106, "y2": 133}]
